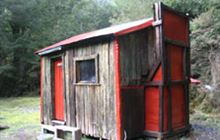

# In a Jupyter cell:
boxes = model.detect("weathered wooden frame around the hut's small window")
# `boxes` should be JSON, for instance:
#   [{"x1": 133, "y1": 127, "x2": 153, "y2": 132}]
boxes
[{"x1": 73, "y1": 54, "x2": 100, "y2": 85}]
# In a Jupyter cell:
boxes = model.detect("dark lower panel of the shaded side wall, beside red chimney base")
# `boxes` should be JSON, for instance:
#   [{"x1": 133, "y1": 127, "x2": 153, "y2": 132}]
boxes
[{"x1": 121, "y1": 87, "x2": 145, "y2": 139}]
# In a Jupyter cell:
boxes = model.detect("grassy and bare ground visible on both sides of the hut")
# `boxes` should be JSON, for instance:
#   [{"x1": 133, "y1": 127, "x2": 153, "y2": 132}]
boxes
[{"x1": 0, "y1": 97, "x2": 220, "y2": 140}]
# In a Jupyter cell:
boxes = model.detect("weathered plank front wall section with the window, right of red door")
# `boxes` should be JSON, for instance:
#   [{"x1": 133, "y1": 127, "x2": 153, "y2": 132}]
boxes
[{"x1": 65, "y1": 42, "x2": 116, "y2": 139}]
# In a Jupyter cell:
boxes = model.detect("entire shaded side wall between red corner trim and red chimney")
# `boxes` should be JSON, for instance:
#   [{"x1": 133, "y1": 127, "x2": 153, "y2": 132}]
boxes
[{"x1": 119, "y1": 28, "x2": 159, "y2": 138}]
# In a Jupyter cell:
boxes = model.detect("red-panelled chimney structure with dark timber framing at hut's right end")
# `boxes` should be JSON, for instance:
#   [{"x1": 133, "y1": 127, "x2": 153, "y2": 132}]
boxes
[{"x1": 145, "y1": 3, "x2": 190, "y2": 137}]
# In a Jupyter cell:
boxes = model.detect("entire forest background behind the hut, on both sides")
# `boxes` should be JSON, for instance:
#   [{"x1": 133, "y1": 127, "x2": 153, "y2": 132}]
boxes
[{"x1": 0, "y1": 0, "x2": 220, "y2": 113}]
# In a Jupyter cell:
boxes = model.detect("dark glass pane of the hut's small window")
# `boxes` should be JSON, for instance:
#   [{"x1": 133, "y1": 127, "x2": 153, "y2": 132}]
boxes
[{"x1": 77, "y1": 59, "x2": 96, "y2": 83}]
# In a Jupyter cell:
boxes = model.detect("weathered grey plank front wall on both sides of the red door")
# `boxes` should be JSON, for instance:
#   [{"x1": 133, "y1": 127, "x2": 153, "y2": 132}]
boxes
[{"x1": 41, "y1": 42, "x2": 116, "y2": 139}]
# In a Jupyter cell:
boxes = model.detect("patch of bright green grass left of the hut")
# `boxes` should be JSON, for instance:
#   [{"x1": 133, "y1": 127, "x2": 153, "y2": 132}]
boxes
[{"x1": 0, "y1": 97, "x2": 40, "y2": 140}]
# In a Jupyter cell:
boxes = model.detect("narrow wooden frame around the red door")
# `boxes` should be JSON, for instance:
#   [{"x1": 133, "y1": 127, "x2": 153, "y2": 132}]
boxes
[{"x1": 50, "y1": 53, "x2": 67, "y2": 124}]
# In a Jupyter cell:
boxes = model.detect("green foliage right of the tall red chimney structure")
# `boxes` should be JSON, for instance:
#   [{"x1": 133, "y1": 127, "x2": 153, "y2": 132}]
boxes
[{"x1": 191, "y1": 1, "x2": 220, "y2": 113}]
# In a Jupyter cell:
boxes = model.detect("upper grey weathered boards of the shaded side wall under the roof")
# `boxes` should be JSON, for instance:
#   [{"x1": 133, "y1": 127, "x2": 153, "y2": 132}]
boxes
[{"x1": 119, "y1": 28, "x2": 159, "y2": 86}]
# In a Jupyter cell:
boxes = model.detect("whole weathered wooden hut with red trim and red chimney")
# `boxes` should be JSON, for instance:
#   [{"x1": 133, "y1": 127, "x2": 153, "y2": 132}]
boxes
[{"x1": 36, "y1": 3, "x2": 190, "y2": 140}]
